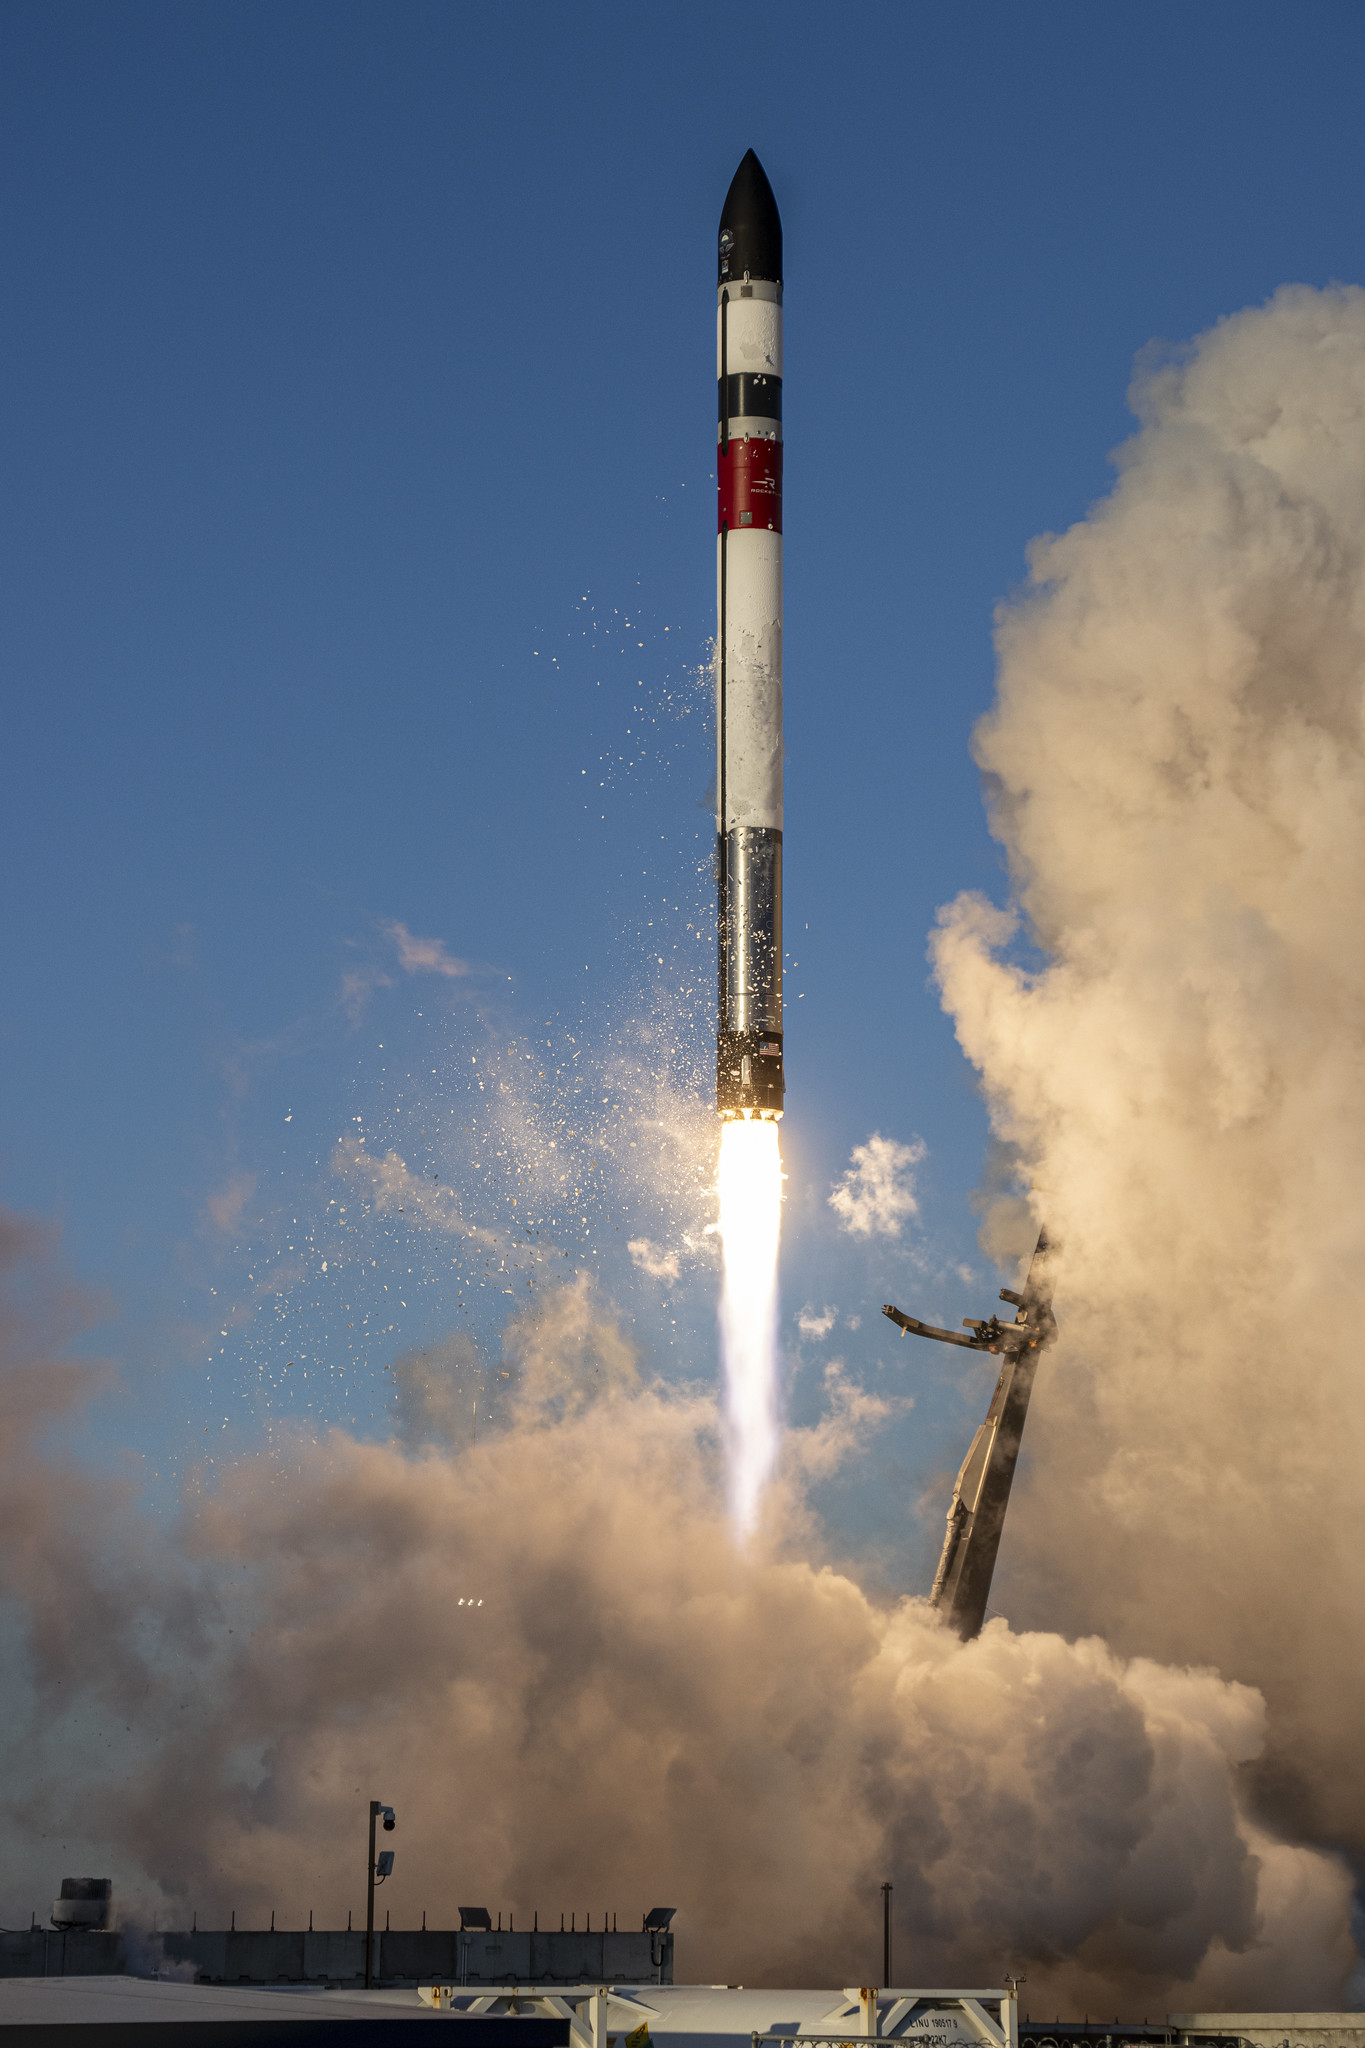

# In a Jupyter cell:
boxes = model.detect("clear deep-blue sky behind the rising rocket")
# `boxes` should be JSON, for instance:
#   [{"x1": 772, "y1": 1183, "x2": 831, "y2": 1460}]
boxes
[{"x1": 0, "y1": 0, "x2": 1365, "y2": 1587}]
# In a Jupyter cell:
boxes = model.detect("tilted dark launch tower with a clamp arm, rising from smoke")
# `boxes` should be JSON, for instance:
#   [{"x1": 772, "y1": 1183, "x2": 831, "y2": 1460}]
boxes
[{"x1": 882, "y1": 1231, "x2": 1056, "y2": 1642}]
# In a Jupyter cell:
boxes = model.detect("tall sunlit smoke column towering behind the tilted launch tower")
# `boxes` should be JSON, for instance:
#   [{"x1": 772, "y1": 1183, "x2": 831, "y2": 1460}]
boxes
[{"x1": 935, "y1": 287, "x2": 1365, "y2": 1872}]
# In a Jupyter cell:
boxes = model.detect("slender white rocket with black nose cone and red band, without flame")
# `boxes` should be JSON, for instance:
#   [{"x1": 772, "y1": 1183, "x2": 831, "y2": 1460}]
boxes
[{"x1": 716, "y1": 150, "x2": 784, "y2": 1116}]
